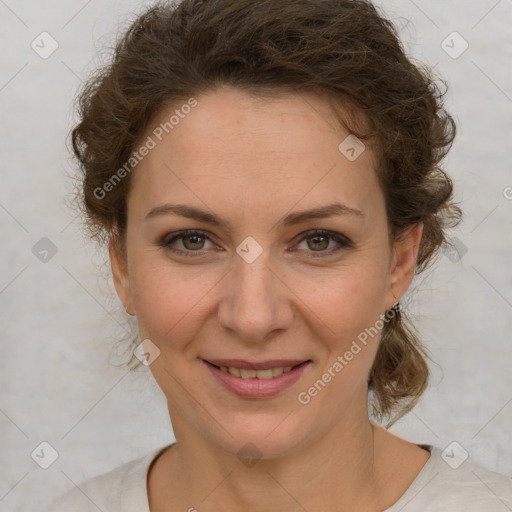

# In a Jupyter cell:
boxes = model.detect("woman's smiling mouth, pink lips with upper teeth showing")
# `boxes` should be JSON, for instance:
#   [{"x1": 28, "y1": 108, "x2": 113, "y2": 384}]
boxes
[{"x1": 202, "y1": 359, "x2": 313, "y2": 398}]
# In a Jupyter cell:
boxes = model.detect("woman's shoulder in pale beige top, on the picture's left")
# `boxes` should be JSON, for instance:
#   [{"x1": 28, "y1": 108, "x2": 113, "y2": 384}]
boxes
[{"x1": 49, "y1": 447, "x2": 166, "y2": 512}]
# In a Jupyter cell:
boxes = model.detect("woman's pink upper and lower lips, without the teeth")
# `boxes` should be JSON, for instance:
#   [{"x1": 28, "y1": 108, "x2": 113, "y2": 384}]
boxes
[{"x1": 202, "y1": 359, "x2": 312, "y2": 398}]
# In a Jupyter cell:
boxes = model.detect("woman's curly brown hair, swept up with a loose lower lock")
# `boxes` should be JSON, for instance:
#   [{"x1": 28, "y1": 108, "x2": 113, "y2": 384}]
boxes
[{"x1": 71, "y1": 0, "x2": 462, "y2": 426}]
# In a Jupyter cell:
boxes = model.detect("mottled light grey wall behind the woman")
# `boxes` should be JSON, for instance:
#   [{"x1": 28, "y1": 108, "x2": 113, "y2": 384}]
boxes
[{"x1": 0, "y1": 0, "x2": 512, "y2": 511}]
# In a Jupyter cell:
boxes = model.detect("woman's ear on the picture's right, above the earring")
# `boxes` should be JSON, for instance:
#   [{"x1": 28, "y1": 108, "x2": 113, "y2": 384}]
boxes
[{"x1": 388, "y1": 222, "x2": 423, "y2": 308}]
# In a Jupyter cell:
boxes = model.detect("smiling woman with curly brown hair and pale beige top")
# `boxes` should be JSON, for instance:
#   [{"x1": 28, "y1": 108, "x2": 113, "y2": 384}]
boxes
[{"x1": 53, "y1": 0, "x2": 512, "y2": 512}]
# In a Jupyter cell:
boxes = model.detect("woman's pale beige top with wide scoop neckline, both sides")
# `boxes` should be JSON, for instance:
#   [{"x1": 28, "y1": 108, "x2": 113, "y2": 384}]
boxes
[{"x1": 49, "y1": 445, "x2": 512, "y2": 512}]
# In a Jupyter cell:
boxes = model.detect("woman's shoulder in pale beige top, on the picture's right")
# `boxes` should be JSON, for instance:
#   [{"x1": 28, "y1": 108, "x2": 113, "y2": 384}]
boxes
[{"x1": 388, "y1": 446, "x2": 512, "y2": 512}]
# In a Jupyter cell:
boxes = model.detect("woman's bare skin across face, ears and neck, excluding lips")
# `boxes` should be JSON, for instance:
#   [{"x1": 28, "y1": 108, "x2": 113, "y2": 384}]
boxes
[{"x1": 110, "y1": 86, "x2": 429, "y2": 512}]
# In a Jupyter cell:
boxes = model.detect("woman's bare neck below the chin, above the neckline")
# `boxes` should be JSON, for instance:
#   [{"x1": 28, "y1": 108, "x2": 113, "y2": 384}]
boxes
[{"x1": 159, "y1": 400, "x2": 396, "y2": 512}]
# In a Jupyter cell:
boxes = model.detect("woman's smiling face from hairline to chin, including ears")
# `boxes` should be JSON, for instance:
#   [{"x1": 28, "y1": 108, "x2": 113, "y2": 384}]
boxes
[{"x1": 110, "y1": 87, "x2": 421, "y2": 457}]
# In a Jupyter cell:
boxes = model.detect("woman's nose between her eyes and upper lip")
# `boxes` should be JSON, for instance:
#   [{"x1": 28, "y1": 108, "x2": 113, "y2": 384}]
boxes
[{"x1": 218, "y1": 250, "x2": 294, "y2": 343}]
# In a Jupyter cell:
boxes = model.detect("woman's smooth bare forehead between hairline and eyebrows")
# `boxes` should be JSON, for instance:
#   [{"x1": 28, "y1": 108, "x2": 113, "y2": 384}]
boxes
[{"x1": 130, "y1": 86, "x2": 380, "y2": 224}]
